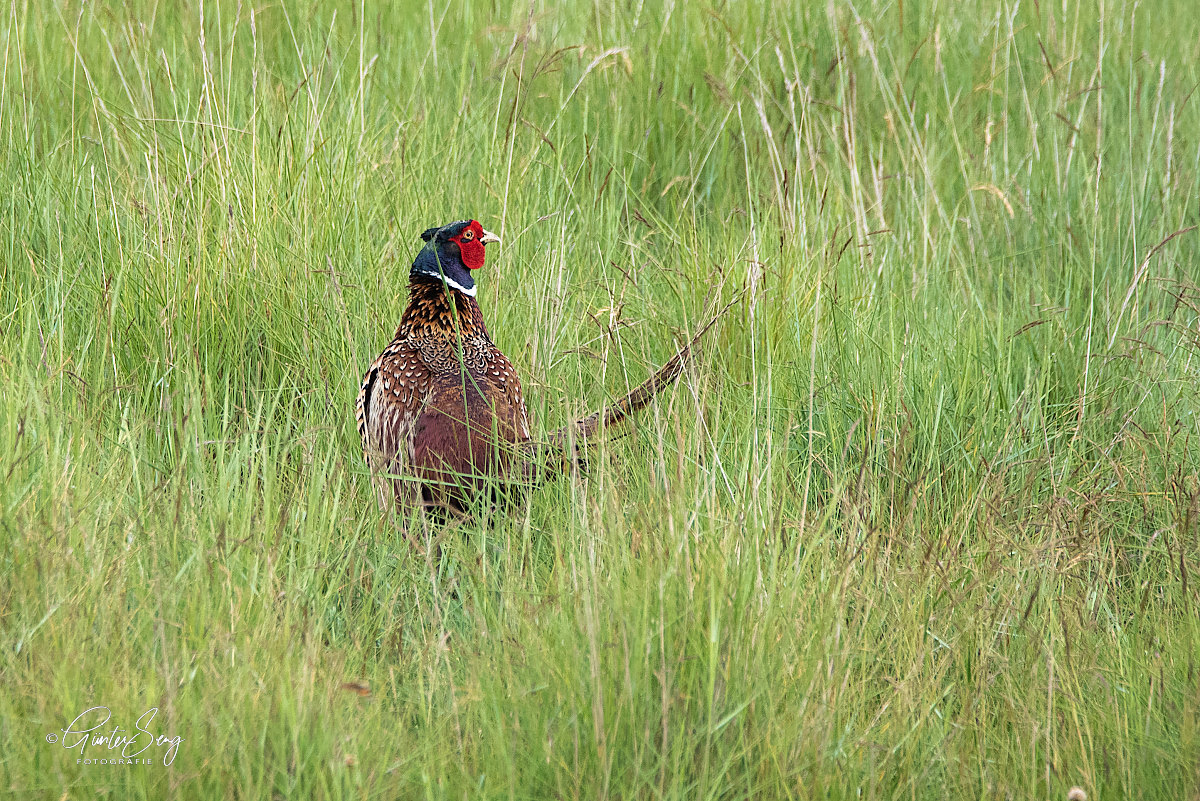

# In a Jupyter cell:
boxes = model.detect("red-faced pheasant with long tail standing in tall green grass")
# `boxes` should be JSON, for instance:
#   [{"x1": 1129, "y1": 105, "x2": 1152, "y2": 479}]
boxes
[{"x1": 355, "y1": 219, "x2": 712, "y2": 512}]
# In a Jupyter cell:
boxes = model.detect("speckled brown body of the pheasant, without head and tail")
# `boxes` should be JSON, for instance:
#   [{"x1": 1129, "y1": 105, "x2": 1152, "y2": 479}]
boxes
[{"x1": 356, "y1": 277, "x2": 529, "y2": 510}]
